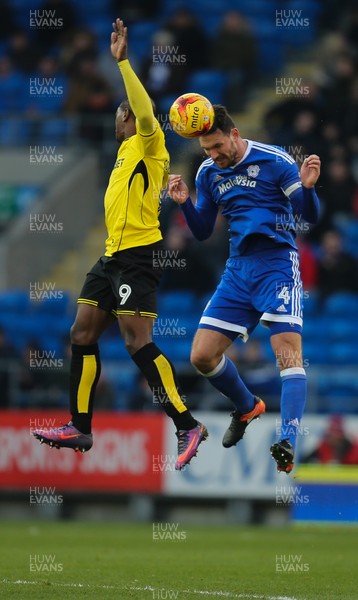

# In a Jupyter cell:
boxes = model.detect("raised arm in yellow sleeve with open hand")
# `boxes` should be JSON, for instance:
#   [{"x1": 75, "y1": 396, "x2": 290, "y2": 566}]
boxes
[{"x1": 111, "y1": 19, "x2": 156, "y2": 135}]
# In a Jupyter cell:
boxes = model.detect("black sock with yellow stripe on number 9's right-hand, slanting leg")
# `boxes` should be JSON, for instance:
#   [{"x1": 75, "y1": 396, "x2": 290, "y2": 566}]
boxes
[{"x1": 132, "y1": 342, "x2": 197, "y2": 430}]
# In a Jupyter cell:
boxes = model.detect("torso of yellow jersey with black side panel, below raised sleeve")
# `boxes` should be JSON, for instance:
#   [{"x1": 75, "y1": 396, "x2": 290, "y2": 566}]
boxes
[{"x1": 104, "y1": 121, "x2": 169, "y2": 256}]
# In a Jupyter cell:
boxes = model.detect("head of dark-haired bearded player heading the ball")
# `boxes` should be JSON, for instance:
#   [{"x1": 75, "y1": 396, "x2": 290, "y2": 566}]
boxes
[{"x1": 199, "y1": 104, "x2": 246, "y2": 169}]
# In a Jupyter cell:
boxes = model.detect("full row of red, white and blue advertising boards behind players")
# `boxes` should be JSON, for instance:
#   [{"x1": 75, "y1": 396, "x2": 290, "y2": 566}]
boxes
[{"x1": 0, "y1": 410, "x2": 358, "y2": 520}]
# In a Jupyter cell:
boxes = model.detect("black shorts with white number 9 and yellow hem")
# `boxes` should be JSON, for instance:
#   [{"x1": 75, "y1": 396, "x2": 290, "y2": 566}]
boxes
[{"x1": 77, "y1": 241, "x2": 163, "y2": 318}]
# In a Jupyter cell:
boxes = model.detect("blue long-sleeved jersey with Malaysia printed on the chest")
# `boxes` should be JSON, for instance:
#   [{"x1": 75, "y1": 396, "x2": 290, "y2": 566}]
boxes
[{"x1": 181, "y1": 140, "x2": 319, "y2": 257}]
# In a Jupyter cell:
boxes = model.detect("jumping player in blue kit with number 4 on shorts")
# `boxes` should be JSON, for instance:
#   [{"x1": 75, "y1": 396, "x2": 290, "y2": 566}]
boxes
[{"x1": 169, "y1": 105, "x2": 320, "y2": 473}]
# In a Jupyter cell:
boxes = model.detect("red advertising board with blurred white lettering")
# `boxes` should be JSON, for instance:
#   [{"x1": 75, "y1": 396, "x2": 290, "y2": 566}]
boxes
[{"x1": 0, "y1": 411, "x2": 165, "y2": 492}]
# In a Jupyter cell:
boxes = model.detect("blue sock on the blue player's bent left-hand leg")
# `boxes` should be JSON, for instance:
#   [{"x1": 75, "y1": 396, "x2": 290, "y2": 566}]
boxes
[{"x1": 202, "y1": 355, "x2": 255, "y2": 414}]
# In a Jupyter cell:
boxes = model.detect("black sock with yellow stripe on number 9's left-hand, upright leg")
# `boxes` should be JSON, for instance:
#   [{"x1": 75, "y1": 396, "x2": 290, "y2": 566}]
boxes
[{"x1": 70, "y1": 344, "x2": 101, "y2": 433}]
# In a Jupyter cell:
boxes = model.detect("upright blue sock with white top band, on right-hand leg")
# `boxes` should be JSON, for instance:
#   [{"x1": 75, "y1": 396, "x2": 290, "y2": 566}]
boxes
[{"x1": 280, "y1": 367, "x2": 307, "y2": 448}]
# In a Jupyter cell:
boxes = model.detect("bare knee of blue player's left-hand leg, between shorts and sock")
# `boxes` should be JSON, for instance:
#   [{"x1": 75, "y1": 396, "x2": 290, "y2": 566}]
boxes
[{"x1": 190, "y1": 328, "x2": 232, "y2": 366}]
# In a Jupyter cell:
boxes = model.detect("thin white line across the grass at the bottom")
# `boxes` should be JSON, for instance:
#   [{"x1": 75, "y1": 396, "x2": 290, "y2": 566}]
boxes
[{"x1": 1, "y1": 579, "x2": 303, "y2": 600}]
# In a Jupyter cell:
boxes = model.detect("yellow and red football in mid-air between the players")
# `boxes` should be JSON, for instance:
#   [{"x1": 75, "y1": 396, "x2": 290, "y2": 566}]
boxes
[{"x1": 169, "y1": 93, "x2": 215, "y2": 138}]
